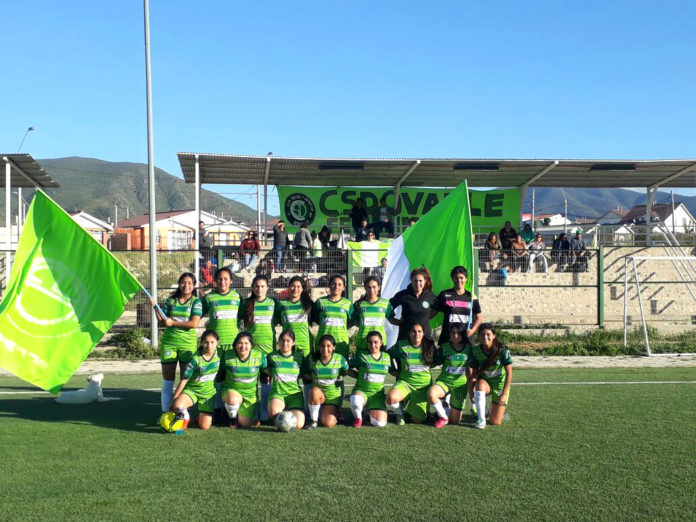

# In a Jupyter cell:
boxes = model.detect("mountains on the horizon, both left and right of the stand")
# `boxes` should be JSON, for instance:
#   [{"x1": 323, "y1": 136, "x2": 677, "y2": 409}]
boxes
[{"x1": 0, "y1": 157, "x2": 696, "y2": 224}]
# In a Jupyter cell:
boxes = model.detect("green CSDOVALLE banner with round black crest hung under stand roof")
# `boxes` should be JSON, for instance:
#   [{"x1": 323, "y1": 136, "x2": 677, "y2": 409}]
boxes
[{"x1": 277, "y1": 186, "x2": 520, "y2": 233}]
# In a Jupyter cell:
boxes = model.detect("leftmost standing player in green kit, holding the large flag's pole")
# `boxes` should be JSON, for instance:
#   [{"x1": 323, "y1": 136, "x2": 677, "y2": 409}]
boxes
[{"x1": 150, "y1": 272, "x2": 202, "y2": 412}]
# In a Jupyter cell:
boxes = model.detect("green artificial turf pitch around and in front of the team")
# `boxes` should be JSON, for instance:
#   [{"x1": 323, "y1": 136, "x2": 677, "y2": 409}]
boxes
[{"x1": 0, "y1": 368, "x2": 696, "y2": 520}]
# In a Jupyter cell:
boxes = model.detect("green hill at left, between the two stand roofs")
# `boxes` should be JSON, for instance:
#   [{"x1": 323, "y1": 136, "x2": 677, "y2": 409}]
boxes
[{"x1": 13, "y1": 157, "x2": 270, "y2": 223}]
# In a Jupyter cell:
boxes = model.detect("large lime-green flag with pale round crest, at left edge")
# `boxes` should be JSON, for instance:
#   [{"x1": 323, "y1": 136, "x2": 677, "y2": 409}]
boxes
[{"x1": 0, "y1": 190, "x2": 142, "y2": 393}]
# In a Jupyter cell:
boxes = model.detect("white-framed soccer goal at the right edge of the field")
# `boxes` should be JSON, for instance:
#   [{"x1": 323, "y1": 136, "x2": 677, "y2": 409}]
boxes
[{"x1": 623, "y1": 252, "x2": 696, "y2": 357}]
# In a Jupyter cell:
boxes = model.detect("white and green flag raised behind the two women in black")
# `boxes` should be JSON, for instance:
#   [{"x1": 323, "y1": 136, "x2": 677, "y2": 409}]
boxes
[{"x1": 382, "y1": 181, "x2": 476, "y2": 345}]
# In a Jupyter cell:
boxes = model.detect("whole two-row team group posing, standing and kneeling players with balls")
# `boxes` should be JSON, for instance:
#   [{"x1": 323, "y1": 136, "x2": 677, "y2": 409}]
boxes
[{"x1": 152, "y1": 266, "x2": 512, "y2": 431}]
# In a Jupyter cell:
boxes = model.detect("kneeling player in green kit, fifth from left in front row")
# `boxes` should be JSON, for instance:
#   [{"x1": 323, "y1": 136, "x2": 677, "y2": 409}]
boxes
[{"x1": 348, "y1": 330, "x2": 391, "y2": 428}]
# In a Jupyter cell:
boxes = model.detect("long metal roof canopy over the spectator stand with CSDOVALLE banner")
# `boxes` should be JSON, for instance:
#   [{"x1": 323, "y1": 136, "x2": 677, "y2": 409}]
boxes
[{"x1": 178, "y1": 152, "x2": 696, "y2": 188}]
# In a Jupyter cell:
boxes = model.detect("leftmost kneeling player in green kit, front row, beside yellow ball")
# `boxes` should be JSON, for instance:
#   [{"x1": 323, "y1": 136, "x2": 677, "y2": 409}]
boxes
[{"x1": 168, "y1": 330, "x2": 220, "y2": 430}]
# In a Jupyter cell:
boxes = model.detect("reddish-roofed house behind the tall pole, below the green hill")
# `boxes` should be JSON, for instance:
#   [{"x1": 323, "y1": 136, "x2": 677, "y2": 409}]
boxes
[{"x1": 113, "y1": 210, "x2": 249, "y2": 250}]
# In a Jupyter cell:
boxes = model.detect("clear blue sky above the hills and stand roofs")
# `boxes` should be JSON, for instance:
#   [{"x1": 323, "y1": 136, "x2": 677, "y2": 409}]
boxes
[{"x1": 0, "y1": 0, "x2": 696, "y2": 210}]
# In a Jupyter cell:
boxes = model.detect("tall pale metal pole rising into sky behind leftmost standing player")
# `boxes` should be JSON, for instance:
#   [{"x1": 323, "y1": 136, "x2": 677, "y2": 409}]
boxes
[{"x1": 143, "y1": 0, "x2": 159, "y2": 346}]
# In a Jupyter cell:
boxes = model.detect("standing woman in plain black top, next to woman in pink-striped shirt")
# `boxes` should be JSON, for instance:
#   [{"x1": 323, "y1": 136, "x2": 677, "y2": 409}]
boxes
[{"x1": 389, "y1": 268, "x2": 435, "y2": 341}]
